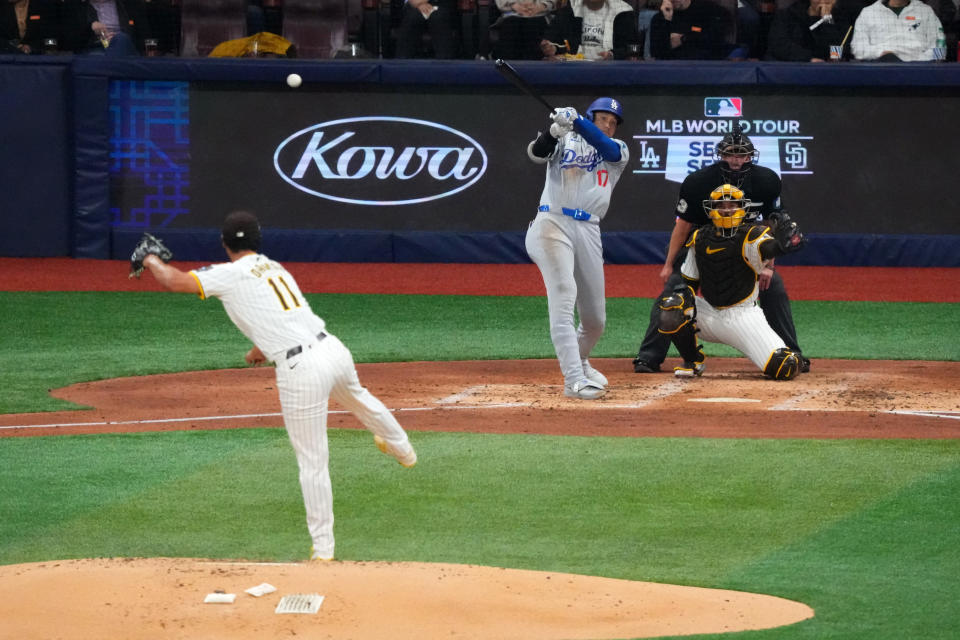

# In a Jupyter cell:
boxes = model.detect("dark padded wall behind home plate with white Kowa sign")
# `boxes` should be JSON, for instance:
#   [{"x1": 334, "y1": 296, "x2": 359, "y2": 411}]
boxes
[{"x1": 0, "y1": 56, "x2": 960, "y2": 267}]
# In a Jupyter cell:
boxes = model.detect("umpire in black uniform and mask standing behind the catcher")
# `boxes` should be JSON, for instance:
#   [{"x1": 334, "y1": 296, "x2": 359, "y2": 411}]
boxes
[{"x1": 633, "y1": 123, "x2": 810, "y2": 373}]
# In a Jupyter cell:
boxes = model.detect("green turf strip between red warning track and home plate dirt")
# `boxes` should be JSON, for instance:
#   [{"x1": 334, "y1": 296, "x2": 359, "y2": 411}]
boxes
[{"x1": 0, "y1": 292, "x2": 960, "y2": 413}]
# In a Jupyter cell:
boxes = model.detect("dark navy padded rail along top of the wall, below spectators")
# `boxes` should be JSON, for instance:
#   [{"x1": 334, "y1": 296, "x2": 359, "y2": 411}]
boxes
[{"x1": 0, "y1": 55, "x2": 960, "y2": 89}]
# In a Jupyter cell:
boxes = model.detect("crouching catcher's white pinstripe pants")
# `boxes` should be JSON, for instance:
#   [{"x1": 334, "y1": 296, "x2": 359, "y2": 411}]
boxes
[{"x1": 696, "y1": 296, "x2": 787, "y2": 371}]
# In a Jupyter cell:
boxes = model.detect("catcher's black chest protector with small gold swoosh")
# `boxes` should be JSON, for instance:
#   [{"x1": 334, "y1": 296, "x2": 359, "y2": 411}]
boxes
[{"x1": 695, "y1": 225, "x2": 757, "y2": 309}]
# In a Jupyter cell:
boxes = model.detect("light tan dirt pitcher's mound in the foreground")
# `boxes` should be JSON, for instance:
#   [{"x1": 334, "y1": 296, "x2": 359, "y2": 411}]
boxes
[{"x1": 0, "y1": 558, "x2": 813, "y2": 640}]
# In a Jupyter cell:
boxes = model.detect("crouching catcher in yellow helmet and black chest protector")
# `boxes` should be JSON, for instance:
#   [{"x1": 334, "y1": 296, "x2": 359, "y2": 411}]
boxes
[{"x1": 656, "y1": 184, "x2": 803, "y2": 380}]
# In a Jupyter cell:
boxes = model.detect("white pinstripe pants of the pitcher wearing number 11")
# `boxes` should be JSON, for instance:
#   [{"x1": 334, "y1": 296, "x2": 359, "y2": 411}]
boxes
[{"x1": 277, "y1": 334, "x2": 409, "y2": 557}]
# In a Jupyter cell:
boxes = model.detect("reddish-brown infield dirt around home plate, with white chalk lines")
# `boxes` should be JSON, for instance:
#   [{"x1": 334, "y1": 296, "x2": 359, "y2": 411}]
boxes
[{"x1": 0, "y1": 358, "x2": 960, "y2": 438}]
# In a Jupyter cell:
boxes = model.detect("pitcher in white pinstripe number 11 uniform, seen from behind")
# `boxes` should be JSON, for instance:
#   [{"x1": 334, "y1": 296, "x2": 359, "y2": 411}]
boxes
[{"x1": 143, "y1": 211, "x2": 417, "y2": 561}]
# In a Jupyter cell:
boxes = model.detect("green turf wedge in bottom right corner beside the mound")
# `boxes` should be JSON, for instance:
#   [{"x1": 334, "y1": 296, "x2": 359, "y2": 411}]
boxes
[{"x1": 680, "y1": 456, "x2": 960, "y2": 640}]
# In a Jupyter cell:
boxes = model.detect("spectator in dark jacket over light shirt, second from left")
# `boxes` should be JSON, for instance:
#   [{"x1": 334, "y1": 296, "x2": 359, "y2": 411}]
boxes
[{"x1": 62, "y1": 0, "x2": 153, "y2": 56}]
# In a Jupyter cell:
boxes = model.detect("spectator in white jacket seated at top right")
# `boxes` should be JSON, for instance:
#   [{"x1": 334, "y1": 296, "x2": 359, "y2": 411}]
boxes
[{"x1": 850, "y1": 0, "x2": 943, "y2": 62}]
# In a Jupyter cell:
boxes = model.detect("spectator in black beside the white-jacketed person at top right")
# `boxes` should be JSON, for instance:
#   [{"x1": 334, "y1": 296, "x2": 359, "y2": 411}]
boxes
[{"x1": 767, "y1": 0, "x2": 853, "y2": 62}]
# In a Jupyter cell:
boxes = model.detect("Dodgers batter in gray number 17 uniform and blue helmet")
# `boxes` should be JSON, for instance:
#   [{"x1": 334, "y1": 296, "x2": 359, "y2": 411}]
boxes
[{"x1": 526, "y1": 98, "x2": 629, "y2": 400}]
